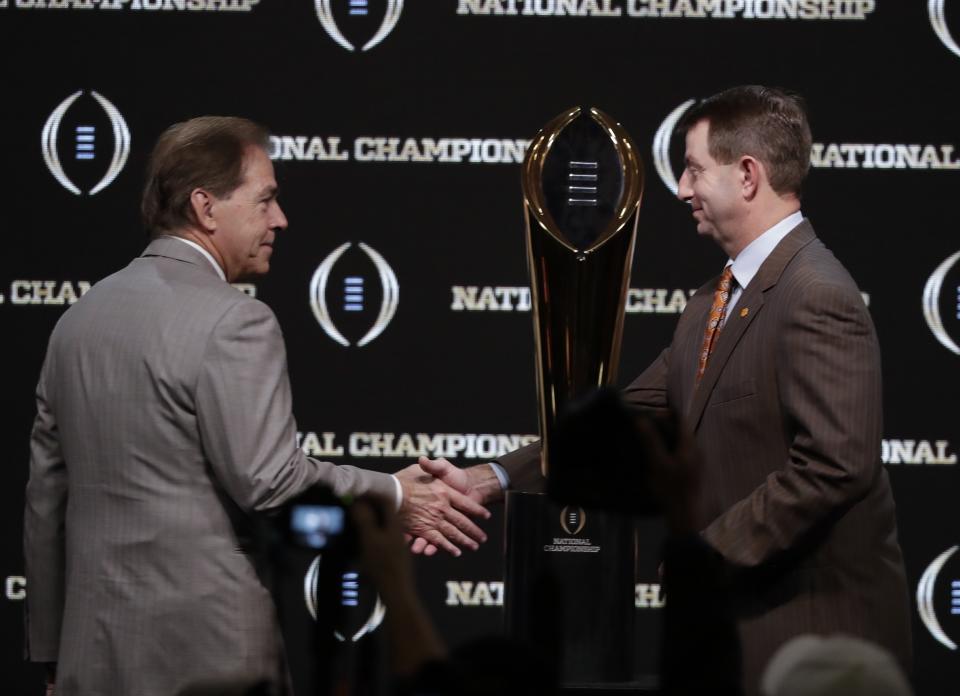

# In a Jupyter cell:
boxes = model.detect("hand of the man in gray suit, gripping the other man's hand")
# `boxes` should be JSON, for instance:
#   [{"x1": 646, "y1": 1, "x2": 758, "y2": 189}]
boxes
[{"x1": 396, "y1": 457, "x2": 490, "y2": 556}]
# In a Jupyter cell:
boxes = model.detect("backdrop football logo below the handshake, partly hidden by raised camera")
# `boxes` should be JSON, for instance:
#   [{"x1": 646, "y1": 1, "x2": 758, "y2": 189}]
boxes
[{"x1": 303, "y1": 555, "x2": 387, "y2": 643}]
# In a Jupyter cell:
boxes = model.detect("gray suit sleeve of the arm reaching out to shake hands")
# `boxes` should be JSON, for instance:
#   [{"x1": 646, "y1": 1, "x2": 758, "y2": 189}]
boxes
[{"x1": 197, "y1": 302, "x2": 396, "y2": 510}]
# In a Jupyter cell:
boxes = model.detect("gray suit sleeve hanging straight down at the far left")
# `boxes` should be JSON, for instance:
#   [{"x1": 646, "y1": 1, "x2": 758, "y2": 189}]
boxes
[{"x1": 23, "y1": 350, "x2": 67, "y2": 662}]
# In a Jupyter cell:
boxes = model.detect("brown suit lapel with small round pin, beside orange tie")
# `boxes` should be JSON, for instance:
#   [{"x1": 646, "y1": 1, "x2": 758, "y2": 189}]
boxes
[{"x1": 687, "y1": 220, "x2": 816, "y2": 430}]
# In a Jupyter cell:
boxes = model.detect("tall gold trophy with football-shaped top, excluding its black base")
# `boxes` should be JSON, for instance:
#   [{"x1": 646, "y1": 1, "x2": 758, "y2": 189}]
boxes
[{"x1": 523, "y1": 107, "x2": 643, "y2": 478}]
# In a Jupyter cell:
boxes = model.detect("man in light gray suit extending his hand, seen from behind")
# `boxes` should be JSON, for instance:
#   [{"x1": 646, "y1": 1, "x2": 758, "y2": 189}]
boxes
[{"x1": 24, "y1": 117, "x2": 487, "y2": 696}]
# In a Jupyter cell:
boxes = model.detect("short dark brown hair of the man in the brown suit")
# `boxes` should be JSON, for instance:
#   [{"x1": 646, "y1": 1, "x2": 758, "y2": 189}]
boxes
[{"x1": 680, "y1": 85, "x2": 813, "y2": 196}]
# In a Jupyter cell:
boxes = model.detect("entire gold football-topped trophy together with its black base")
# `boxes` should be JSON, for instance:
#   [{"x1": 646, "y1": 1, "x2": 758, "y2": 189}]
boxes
[{"x1": 504, "y1": 107, "x2": 643, "y2": 687}]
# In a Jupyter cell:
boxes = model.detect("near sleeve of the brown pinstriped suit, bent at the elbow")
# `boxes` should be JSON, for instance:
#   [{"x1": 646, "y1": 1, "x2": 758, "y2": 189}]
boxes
[{"x1": 704, "y1": 284, "x2": 882, "y2": 567}]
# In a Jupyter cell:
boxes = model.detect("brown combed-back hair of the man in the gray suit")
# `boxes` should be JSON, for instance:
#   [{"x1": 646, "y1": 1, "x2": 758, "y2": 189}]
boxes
[{"x1": 140, "y1": 116, "x2": 269, "y2": 237}]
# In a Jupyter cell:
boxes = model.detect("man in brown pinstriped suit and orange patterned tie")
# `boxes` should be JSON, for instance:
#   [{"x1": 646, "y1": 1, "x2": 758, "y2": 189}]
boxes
[{"x1": 417, "y1": 86, "x2": 911, "y2": 694}]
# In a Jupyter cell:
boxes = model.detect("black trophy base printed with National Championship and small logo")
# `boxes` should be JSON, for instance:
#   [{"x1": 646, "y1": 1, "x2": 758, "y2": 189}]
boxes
[{"x1": 504, "y1": 491, "x2": 643, "y2": 694}]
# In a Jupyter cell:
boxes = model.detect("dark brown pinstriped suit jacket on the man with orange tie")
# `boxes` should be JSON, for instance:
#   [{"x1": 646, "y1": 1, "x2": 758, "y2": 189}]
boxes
[{"x1": 500, "y1": 220, "x2": 911, "y2": 694}]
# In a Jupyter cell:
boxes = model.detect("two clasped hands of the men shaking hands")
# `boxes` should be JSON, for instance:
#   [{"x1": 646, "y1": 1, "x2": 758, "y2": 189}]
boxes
[{"x1": 396, "y1": 457, "x2": 503, "y2": 556}]
